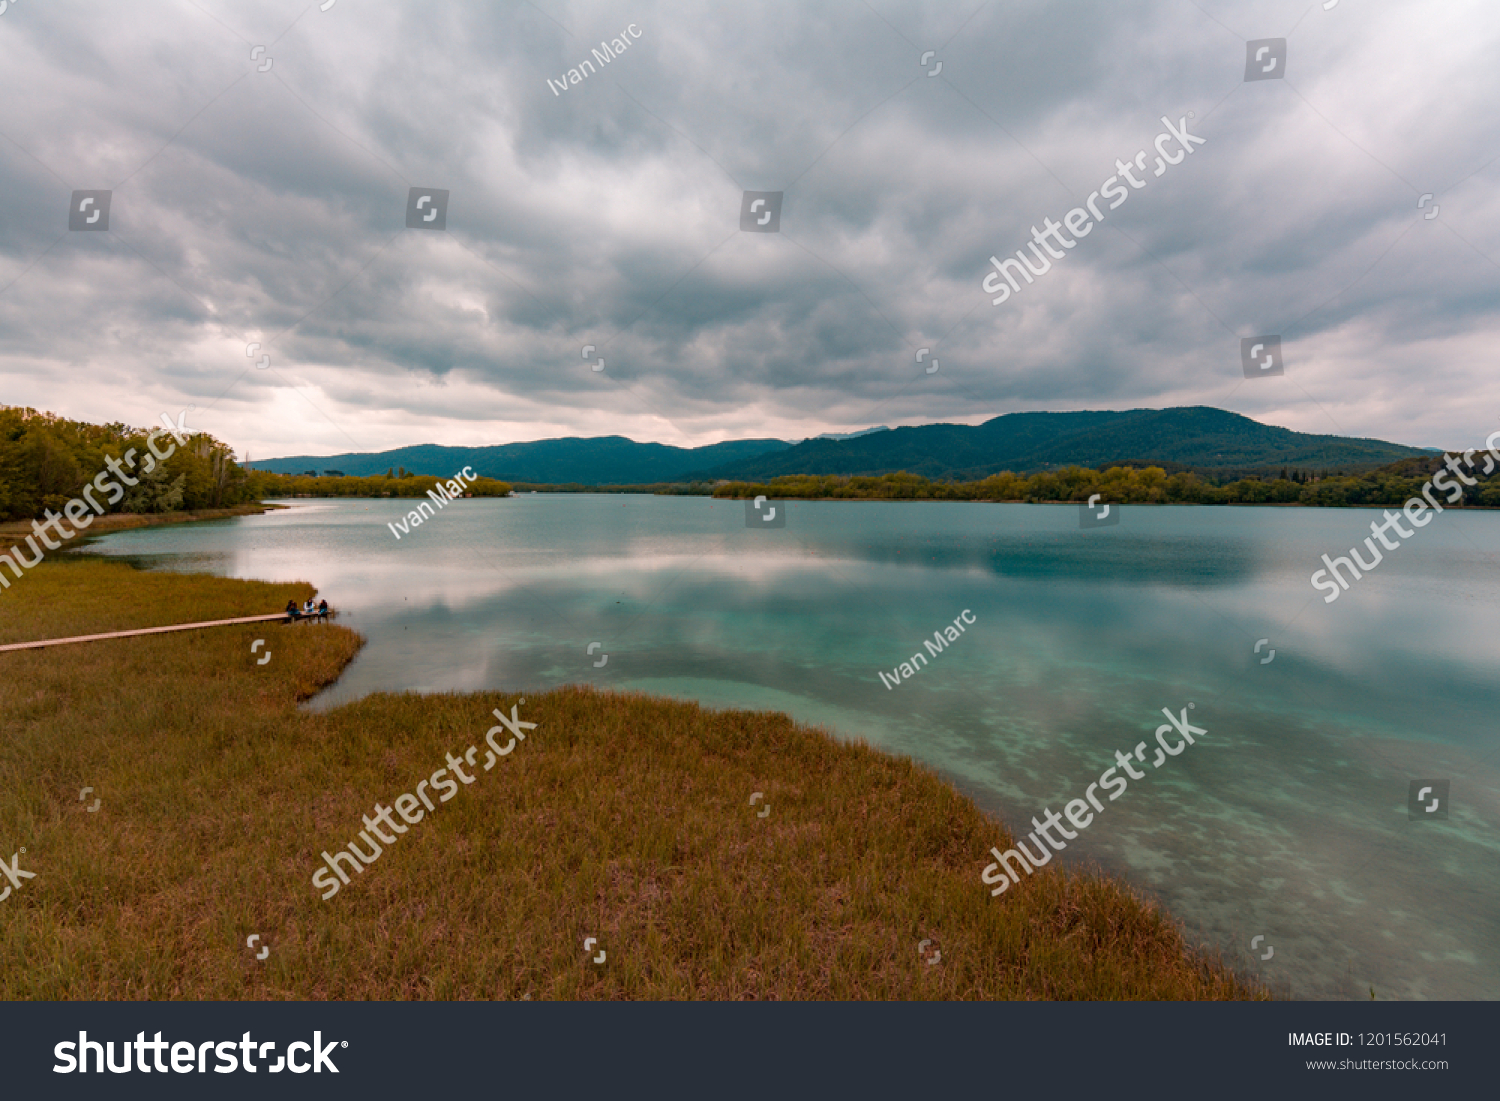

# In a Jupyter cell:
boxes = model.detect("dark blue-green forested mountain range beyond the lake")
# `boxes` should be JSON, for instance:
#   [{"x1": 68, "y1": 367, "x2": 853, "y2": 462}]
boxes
[{"x1": 261, "y1": 405, "x2": 1431, "y2": 486}]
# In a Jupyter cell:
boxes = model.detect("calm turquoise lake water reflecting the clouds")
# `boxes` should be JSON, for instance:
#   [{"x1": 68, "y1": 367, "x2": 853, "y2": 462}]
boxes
[{"x1": 82, "y1": 495, "x2": 1500, "y2": 999}]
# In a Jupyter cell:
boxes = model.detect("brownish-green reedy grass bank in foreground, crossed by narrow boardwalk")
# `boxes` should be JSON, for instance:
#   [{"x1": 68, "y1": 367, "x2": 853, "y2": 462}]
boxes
[{"x1": 0, "y1": 560, "x2": 1265, "y2": 1001}]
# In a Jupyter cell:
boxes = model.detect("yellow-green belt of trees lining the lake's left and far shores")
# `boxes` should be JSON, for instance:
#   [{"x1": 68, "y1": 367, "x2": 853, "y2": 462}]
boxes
[{"x1": 0, "y1": 405, "x2": 1500, "y2": 525}]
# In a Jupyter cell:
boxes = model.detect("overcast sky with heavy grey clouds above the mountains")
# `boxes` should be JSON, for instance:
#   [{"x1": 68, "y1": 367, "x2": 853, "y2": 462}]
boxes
[{"x1": 0, "y1": 0, "x2": 1500, "y2": 458}]
